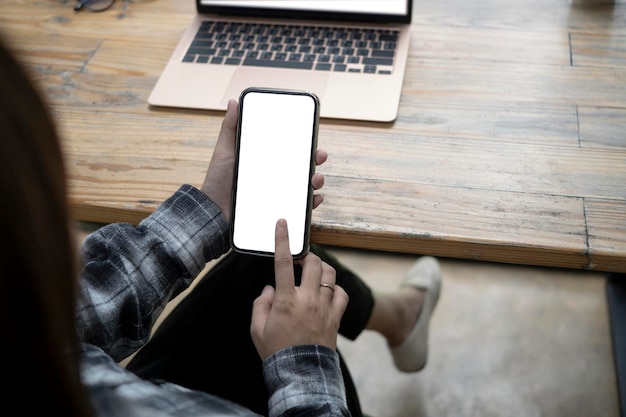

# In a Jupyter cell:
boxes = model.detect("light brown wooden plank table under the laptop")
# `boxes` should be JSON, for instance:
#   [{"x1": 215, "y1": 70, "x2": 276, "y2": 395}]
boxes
[{"x1": 0, "y1": 0, "x2": 626, "y2": 272}]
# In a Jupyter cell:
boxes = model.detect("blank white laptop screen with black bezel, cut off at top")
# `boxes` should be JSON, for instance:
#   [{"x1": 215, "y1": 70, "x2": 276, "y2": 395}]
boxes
[{"x1": 196, "y1": 0, "x2": 411, "y2": 23}]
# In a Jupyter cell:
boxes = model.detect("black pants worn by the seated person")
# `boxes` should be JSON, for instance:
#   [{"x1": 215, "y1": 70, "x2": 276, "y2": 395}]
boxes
[{"x1": 127, "y1": 245, "x2": 374, "y2": 417}]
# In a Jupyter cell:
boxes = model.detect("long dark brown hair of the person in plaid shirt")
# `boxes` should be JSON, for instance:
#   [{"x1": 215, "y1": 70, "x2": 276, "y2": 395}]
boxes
[{"x1": 0, "y1": 35, "x2": 91, "y2": 416}]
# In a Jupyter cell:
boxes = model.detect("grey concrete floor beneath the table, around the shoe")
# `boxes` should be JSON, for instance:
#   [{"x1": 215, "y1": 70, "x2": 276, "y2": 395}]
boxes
[{"x1": 333, "y1": 249, "x2": 620, "y2": 417}]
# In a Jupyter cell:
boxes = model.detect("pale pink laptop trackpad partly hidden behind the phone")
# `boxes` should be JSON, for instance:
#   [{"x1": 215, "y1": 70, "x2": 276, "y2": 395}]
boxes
[{"x1": 223, "y1": 67, "x2": 328, "y2": 107}]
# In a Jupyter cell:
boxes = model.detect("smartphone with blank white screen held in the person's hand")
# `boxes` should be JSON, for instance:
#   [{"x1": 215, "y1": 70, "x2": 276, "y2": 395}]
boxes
[{"x1": 230, "y1": 88, "x2": 320, "y2": 258}]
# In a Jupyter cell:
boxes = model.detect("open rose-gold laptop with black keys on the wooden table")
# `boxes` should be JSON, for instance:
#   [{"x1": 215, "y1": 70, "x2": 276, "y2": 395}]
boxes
[{"x1": 148, "y1": 0, "x2": 412, "y2": 122}]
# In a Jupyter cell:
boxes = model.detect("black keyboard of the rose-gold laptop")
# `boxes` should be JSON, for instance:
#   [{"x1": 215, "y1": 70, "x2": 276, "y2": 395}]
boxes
[{"x1": 183, "y1": 21, "x2": 399, "y2": 74}]
